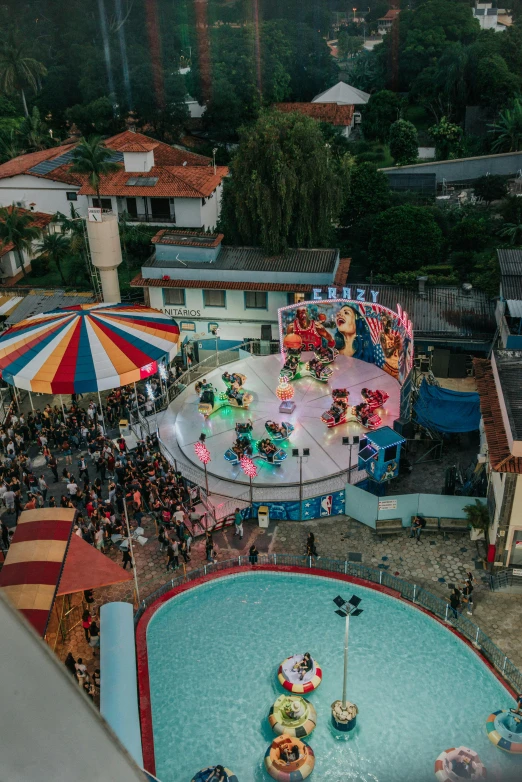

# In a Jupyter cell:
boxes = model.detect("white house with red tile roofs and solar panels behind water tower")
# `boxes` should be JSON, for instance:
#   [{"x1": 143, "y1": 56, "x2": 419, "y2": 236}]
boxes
[{"x1": 0, "y1": 131, "x2": 223, "y2": 230}]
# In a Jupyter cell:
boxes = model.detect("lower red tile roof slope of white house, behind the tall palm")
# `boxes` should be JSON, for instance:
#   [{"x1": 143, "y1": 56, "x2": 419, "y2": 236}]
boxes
[{"x1": 79, "y1": 166, "x2": 228, "y2": 198}]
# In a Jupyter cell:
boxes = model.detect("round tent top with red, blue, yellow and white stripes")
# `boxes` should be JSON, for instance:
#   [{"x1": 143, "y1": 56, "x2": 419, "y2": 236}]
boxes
[{"x1": 0, "y1": 304, "x2": 179, "y2": 394}]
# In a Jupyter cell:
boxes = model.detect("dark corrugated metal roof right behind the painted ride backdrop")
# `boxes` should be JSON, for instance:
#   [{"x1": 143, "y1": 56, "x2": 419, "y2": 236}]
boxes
[{"x1": 360, "y1": 283, "x2": 496, "y2": 339}]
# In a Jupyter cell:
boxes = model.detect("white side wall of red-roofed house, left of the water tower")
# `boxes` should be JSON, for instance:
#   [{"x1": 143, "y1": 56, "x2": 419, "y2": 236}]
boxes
[{"x1": 0, "y1": 174, "x2": 87, "y2": 215}]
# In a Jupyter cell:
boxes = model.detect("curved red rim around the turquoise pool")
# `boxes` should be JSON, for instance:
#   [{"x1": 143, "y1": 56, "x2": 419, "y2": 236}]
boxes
[{"x1": 135, "y1": 565, "x2": 516, "y2": 774}]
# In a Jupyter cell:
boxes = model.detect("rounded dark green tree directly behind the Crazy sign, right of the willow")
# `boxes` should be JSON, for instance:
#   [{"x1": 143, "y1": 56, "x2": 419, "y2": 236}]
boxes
[{"x1": 369, "y1": 205, "x2": 443, "y2": 275}]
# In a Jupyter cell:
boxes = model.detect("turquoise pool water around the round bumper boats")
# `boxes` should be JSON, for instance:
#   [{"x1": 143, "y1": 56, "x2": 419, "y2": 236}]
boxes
[{"x1": 147, "y1": 573, "x2": 522, "y2": 782}]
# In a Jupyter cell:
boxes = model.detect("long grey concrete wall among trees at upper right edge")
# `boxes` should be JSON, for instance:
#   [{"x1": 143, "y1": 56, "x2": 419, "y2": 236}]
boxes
[{"x1": 380, "y1": 152, "x2": 522, "y2": 182}]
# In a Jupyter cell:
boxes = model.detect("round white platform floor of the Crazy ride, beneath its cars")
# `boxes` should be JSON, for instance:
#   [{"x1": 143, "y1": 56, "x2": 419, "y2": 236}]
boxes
[{"x1": 160, "y1": 353, "x2": 400, "y2": 487}]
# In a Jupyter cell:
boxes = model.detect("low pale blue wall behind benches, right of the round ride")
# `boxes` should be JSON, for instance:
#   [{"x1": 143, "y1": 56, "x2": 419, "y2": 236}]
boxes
[{"x1": 345, "y1": 484, "x2": 482, "y2": 529}]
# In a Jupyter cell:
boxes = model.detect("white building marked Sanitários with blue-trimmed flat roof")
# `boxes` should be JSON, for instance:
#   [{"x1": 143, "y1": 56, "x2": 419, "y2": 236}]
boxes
[{"x1": 131, "y1": 229, "x2": 349, "y2": 344}]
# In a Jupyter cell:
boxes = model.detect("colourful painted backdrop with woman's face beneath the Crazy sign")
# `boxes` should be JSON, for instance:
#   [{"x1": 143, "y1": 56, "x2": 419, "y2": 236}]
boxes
[{"x1": 279, "y1": 299, "x2": 413, "y2": 385}]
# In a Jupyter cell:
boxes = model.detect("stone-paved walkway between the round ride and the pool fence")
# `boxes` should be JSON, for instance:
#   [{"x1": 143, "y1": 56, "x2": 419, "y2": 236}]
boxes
[{"x1": 57, "y1": 516, "x2": 522, "y2": 700}]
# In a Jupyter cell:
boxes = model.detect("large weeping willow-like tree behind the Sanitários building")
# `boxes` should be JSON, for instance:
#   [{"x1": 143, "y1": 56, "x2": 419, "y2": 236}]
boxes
[{"x1": 220, "y1": 111, "x2": 341, "y2": 253}]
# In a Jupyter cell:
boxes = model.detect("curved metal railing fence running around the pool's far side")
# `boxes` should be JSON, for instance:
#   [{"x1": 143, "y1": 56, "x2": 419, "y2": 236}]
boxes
[{"x1": 134, "y1": 554, "x2": 522, "y2": 692}]
